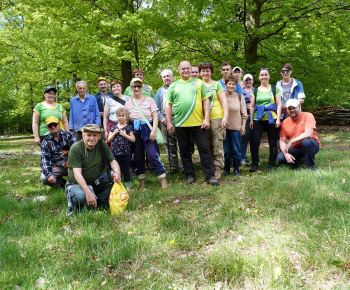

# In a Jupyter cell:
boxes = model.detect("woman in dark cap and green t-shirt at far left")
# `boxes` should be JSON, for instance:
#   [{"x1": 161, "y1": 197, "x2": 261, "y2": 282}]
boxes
[{"x1": 32, "y1": 86, "x2": 69, "y2": 146}]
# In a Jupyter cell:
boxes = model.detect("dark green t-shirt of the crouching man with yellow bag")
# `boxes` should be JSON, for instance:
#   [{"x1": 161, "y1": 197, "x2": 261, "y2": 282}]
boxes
[{"x1": 67, "y1": 140, "x2": 114, "y2": 185}]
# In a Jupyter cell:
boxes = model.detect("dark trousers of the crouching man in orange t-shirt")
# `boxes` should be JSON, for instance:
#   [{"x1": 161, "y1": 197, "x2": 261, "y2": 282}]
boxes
[{"x1": 277, "y1": 139, "x2": 320, "y2": 169}]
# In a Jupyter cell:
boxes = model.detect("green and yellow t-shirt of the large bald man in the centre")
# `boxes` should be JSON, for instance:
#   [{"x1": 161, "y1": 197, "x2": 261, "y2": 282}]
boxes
[{"x1": 167, "y1": 78, "x2": 209, "y2": 127}]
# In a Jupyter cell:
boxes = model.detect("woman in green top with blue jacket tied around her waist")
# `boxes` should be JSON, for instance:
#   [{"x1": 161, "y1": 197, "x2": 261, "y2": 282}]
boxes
[{"x1": 249, "y1": 68, "x2": 281, "y2": 172}]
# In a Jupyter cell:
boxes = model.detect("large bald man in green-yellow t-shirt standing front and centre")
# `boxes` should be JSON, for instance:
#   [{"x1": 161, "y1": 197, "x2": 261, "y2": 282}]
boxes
[{"x1": 165, "y1": 61, "x2": 219, "y2": 185}]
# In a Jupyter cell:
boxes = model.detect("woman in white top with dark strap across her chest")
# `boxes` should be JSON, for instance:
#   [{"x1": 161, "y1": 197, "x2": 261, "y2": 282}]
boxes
[{"x1": 103, "y1": 80, "x2": 129, "y2": 138}]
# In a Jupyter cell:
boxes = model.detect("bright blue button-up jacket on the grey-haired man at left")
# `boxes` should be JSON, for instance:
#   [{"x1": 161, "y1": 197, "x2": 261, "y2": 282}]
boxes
[{"x1": 69, "y1": 94, "x2": 101, "y2": 132}]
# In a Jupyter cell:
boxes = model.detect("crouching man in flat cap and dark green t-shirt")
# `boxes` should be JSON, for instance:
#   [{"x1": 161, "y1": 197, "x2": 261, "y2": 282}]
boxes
[{"x1": 66, "y1": 124, "x2": 120, "y2": 213}]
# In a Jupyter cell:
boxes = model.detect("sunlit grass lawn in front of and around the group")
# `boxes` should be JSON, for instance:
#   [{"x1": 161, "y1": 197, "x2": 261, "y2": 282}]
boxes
[{"x1": 0, "y1": 132, "x2": 350, "y2": 289}]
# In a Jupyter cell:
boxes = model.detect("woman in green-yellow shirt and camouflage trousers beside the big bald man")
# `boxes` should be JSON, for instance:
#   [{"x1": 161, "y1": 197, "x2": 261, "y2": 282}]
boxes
[{"x1": 199, "y1": 62, "x2": 227, "y2": 179}]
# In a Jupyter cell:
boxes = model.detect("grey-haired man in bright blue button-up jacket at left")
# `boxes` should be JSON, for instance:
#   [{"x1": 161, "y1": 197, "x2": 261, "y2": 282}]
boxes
[{"x1": 69, "y1": 81, "x2": 101, "y2": 140}]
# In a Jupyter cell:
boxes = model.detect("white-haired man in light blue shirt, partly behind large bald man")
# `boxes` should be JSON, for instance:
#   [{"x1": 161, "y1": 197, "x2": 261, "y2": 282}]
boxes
[{"x1": 154, "y1": 69, "x2": 179, "y2": 174}]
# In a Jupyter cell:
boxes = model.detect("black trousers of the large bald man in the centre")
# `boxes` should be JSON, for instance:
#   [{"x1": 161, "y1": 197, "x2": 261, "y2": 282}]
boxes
[{"x1": 175, "y1": 126, "x2": 214, "y2": 179}]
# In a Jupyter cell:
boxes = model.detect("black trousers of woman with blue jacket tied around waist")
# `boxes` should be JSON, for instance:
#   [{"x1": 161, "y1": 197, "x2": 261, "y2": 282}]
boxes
[{"x1": 250, "y1": 120, "x2": 278, "y2": 167}]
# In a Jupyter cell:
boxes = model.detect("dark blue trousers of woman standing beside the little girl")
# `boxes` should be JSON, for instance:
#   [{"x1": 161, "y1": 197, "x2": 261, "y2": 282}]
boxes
[{"x1": 135, "y1": 131, "x2": 165, "y2": 176}]
